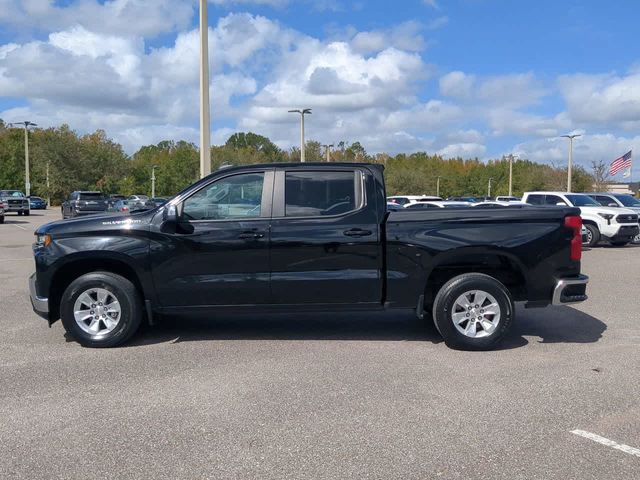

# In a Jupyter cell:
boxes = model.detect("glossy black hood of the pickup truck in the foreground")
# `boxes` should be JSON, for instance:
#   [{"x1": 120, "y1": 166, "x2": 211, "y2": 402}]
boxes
[{"x1": 36, "y1": 208, "x2": 158, "y2": 236}]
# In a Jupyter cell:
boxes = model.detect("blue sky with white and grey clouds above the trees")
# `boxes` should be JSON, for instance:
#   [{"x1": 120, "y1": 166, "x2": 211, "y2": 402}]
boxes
[{"x1": 0, "y1": 0, "x2": 640, "y2": 177}]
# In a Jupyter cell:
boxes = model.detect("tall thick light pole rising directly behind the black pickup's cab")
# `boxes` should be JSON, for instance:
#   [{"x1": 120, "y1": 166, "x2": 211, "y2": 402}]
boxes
[{"x1": 200, "y1": 0, "x2": 211, "y2": 178}]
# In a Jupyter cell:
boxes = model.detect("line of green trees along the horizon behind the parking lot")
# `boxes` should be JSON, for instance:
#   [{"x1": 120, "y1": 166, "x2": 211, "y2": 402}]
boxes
[{"x1": 0, "y1": 120, "x2": 594, "y2": 203}]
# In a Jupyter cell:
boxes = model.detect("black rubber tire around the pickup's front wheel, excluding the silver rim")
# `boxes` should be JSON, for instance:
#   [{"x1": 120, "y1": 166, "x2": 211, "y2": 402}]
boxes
[{"x1": 60, "y1": 272, "x2": 144, "y2": 348}]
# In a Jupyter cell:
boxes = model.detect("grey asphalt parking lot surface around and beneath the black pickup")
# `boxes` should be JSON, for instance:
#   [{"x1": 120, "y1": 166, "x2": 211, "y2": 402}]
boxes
[{"x1": 0, "y1": 209, "x2": 640, "y2": 479}]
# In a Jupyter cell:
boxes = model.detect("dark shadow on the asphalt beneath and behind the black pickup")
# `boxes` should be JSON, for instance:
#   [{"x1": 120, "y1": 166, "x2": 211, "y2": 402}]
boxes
[{"x1": 128, "y1": 307, "x2": 607, "y2": 350}]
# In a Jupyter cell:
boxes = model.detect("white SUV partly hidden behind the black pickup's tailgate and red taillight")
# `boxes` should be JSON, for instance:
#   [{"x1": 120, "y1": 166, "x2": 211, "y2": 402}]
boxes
[{"x1": 522, "y1": 192, "x2": 639, "y2": 246}]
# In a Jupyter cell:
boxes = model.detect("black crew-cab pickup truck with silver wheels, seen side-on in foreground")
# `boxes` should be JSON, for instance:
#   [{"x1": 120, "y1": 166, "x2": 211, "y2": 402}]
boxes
[{"x1": 29, "y1": 163, "x2": 588, "y2": 350}]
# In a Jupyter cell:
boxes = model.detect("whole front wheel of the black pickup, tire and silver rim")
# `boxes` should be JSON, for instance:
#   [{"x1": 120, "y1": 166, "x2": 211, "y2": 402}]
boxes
[{"x1": 60, "y1": 272, "x2": 143, "y2": 348}]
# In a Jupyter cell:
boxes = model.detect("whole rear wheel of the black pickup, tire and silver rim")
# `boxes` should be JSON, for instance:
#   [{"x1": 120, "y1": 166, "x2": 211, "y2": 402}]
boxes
[{"x1": 433, "y1": 273, "x2": 514, "y2": 350}]
